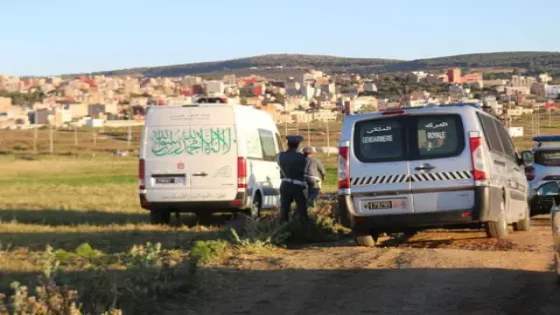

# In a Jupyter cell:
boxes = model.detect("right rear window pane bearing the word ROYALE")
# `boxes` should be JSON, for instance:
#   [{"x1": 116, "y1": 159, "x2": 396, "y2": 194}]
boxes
[{"x1": 416, "y1": 115, "x2": 465, "y2": 159}]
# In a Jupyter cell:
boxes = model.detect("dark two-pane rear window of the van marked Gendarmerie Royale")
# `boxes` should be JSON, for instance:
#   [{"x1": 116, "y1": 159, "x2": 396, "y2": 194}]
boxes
[{"x1": 354, "y1": 114, "x2": 465, "y2": 162}]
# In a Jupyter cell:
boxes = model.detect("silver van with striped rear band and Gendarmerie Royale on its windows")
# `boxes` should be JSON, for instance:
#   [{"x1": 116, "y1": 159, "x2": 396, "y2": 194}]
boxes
[{"x1": 338, "y1": 104, "x2": 530, "y2": 246}]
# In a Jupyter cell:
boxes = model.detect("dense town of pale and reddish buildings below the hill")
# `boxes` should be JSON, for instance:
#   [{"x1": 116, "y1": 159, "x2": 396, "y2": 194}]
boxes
[{"x1": 0, "y1": 68, "x2": 560, "y2": 127}]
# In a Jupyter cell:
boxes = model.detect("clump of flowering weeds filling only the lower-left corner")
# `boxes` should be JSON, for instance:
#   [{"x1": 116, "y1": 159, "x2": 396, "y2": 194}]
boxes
[{"x1": 0, "y1": 243, "x2": 206, "y2": 315}]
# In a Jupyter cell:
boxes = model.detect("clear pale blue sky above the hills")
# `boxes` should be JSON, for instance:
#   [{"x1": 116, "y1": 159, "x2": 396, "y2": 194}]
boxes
[{"x1": 0, "y1": 0, "x2": 560, "y2": 76}]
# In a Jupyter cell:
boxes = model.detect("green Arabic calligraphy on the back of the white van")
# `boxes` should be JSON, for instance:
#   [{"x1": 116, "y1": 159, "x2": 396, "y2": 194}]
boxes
[{"x1": 150, "y1": 128, "x2": 232, "y2": 156}]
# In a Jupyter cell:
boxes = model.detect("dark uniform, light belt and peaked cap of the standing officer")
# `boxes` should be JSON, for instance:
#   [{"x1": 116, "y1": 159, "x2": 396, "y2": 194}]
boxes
[{"x1": 276, "y1": 136, "x2": 309, "y2": 222}]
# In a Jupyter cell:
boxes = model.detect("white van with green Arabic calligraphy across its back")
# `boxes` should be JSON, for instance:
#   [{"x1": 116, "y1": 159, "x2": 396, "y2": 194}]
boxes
[{"x1": 139, "y1": 99, "x2": 282, "y2": 224}]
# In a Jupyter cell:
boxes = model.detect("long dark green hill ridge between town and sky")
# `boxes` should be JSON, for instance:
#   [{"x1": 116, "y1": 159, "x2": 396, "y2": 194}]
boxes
[{"x1": 87, "y1": 52, "x2": 560, "y2": 77}]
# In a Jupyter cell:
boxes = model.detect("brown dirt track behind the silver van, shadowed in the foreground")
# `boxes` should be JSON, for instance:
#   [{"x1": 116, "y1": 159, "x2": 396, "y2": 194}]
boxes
[{"x1": 200, "y1": 219, "x2": 560, "y2": 315}]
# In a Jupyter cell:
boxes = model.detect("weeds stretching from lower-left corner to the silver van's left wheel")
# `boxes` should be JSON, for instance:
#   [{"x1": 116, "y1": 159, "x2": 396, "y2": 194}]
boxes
[{"x1": 0, "y1": 204, "x2": 339, "y2": 315}]
